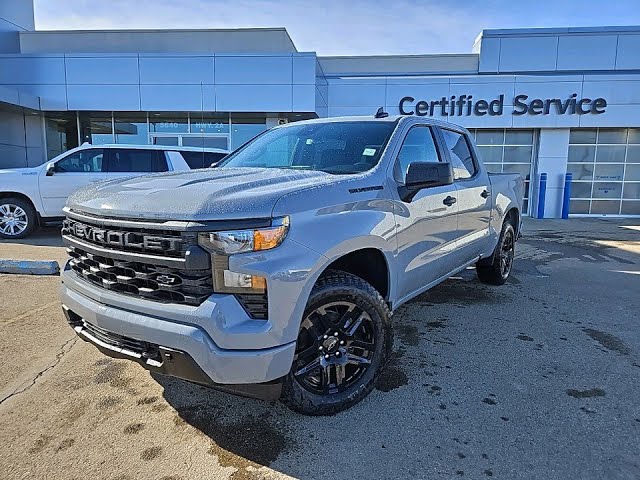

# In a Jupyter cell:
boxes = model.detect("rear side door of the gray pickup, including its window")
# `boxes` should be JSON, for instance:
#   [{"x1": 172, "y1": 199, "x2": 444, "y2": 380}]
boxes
[{"x1": 439, "y1": 128, "x2": 491, "y2": 265}]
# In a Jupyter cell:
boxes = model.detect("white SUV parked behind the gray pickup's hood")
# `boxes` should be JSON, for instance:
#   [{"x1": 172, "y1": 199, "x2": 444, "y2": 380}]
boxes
[{"x1": 0, "y1": 143, "x2": 227, "y2": 238}]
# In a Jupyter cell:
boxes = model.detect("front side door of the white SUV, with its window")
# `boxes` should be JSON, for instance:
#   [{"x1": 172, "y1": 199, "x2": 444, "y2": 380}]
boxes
[{"x1": 38, "y1": 148, "x2": 107, "y2": 217}]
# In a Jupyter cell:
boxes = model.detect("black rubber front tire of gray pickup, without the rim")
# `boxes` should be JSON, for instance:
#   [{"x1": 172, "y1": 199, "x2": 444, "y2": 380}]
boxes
[{"x1": 280, "y1": 270, "x2": 393, "y2": 415}]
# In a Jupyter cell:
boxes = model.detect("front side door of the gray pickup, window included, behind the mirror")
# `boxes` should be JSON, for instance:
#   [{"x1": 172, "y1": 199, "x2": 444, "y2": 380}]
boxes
[{"x1": 393, "y1": 125, "x2": 458, "y2": 298}]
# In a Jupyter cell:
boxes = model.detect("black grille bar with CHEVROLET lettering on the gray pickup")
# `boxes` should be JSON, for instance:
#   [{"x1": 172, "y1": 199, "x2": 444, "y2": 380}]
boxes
[{"x1": 62, "y1": 219, "x2": 181, "y2": 252}]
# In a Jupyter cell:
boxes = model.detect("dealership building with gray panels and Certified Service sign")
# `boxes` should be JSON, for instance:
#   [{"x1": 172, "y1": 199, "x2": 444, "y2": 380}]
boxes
[{"x1": 0, "y1": 0, "x2": 640, "y2": 217}]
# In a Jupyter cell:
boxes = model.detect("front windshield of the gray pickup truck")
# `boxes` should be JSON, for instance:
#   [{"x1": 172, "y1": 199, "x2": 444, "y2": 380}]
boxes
[{"x1": 219, "y1": 121, "x2": 395, "y2": 174}]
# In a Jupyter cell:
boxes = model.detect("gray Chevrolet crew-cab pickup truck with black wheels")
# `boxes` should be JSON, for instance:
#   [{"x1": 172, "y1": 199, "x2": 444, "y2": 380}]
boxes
[{"x1": 61, "y1": 114, "x2": 523, "y2": 415}]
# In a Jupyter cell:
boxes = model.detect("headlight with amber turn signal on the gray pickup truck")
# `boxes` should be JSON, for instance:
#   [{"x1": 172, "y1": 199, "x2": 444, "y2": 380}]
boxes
[{"x1": 198, "y1": 217, "x2": 289, "y2": 255}]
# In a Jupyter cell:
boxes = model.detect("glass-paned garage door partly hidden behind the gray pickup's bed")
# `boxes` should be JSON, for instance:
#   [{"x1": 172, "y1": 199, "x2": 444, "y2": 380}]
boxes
[{"x1": 471, "y1": 128, "x2": 535, "y2": 213}]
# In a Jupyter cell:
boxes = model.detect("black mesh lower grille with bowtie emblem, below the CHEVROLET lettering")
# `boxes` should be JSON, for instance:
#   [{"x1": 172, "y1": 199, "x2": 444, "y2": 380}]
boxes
[{"x1": 67, "y1": 247, "x2": 213, "y2": 305}]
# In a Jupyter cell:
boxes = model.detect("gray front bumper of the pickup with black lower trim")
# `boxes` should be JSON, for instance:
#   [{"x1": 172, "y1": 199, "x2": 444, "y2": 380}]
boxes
[{"x1": 60, "y1": 269, "x2": 295, "y2": 398}]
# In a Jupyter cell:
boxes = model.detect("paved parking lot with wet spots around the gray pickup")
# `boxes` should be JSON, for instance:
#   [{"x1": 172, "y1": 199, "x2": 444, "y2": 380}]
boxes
[{"x1": 0, "y1": 219, "x2": 640, "y2": 480}]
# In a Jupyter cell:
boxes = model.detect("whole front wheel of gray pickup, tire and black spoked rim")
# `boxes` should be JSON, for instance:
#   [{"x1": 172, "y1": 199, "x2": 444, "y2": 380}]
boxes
[{"x1": 281, "y1": 271, "x2": 393, "y2": 415}]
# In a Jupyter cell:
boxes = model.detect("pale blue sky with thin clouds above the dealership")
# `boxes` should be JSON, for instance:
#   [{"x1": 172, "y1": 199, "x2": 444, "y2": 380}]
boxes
[{"x1": 34, "y1": 0, "x2": 640, "y2": 55}]
